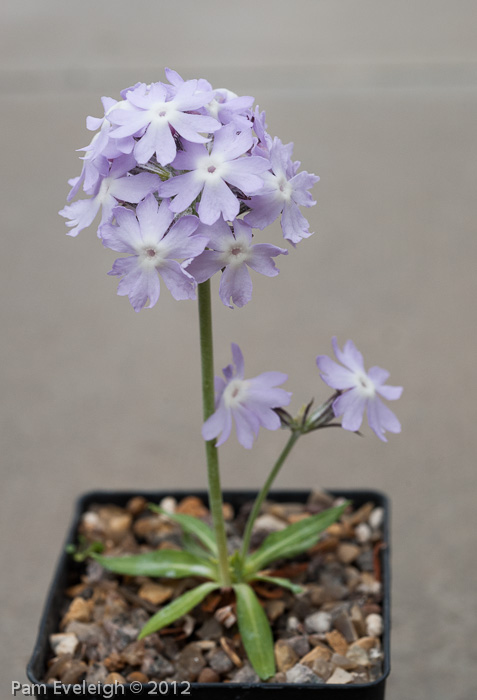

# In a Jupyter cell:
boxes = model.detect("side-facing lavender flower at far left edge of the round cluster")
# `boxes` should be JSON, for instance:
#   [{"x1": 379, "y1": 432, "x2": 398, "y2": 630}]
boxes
[{"x1": 58, "y1": 155, "x2": 160, "y2": 236}]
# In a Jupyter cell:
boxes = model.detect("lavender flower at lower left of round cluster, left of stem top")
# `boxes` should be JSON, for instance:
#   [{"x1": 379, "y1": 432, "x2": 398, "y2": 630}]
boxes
[{"x1": 101, "y1": 194, "x2": 207, "y2": 311}]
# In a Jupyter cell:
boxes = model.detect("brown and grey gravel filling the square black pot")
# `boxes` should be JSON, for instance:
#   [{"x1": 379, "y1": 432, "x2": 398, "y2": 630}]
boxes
[{"x1": 44, "y1": 492, "x2": 383, "y2": 684}]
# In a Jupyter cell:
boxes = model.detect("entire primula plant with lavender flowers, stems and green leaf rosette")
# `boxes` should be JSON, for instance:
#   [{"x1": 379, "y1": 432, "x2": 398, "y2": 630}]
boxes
[{"x1": 60, "y1": 70, "x2": 402, "y2": 679}]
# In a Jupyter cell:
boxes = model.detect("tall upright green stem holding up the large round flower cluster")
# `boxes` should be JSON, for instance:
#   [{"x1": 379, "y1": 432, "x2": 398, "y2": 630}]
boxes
[{"x1": 198, "y1": 280, "x2": 232, "y2": 586}]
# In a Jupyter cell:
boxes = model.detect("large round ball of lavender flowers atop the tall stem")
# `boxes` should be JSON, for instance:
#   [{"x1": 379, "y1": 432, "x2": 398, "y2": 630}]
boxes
[{"x1": 60, "y1": 69, "x2": 319, "y2": 311}]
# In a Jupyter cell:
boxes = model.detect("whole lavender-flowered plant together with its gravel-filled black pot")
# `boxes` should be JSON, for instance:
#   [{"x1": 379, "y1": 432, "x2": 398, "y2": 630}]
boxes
[{"x1": 28, "y1": 69, "x2": 402, "y2": 700}]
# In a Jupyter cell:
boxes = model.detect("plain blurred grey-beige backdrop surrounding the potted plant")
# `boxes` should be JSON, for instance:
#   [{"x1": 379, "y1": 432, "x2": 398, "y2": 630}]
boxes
[{"x1": 0, "y1": 0, "x2": 477, "y2": 700}]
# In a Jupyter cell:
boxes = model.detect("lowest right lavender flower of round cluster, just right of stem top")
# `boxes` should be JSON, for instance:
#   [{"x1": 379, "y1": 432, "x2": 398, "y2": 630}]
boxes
[{"x1": 187, "y1": 218, "x2": 288, "y2": 308}]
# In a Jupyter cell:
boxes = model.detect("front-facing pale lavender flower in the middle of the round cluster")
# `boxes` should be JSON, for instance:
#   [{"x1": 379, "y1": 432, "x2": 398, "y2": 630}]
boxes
[{"x1": 158, "y1": 124, "x2": 270, "y2": 225}]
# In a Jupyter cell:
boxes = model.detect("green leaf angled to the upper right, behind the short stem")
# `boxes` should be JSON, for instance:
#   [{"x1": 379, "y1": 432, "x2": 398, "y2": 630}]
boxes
[{"x1": 245, "y1": 501, "x2": 349, "y2": 577}]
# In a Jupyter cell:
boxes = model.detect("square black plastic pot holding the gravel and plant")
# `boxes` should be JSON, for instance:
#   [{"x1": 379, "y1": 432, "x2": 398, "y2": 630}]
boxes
[{"x1": 27, "y1": 489, "x2": 391, "y2": 700}]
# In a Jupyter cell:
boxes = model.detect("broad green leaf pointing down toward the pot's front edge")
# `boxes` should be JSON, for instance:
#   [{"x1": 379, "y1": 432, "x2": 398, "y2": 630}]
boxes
[{"x1": 234, "y1": 583, "x2": 276, "y2": 680}]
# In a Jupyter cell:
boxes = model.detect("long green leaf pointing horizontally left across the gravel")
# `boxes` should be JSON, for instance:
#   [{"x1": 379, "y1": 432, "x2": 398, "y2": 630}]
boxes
[{"x1": 92, "y1": 549, "x2": 217, "y2": 580}]
